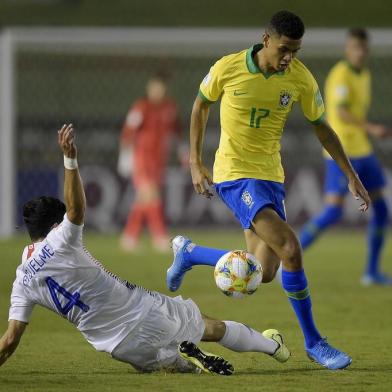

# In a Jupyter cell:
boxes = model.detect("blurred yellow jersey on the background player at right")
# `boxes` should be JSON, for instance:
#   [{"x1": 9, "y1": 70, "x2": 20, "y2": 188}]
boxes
[{"x1": 325, "y1": 61, "x2": 373, "y2": 158}]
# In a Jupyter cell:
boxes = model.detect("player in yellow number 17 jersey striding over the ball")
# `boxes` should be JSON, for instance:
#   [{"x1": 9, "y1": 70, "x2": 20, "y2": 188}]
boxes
[{"x1": 167, "y1": 11, "x2": 369, "y2": 369}]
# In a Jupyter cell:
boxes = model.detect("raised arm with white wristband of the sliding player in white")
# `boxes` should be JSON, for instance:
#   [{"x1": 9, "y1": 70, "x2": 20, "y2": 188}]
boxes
[{"x1": 58, "y1": 124, "x2": 86, "y2": 226}]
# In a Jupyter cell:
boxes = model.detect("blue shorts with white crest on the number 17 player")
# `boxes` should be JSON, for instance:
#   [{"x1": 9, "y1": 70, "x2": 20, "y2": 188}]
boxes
[{"x1": 215, "y1": 178, "x2": 286, "y2": 229}]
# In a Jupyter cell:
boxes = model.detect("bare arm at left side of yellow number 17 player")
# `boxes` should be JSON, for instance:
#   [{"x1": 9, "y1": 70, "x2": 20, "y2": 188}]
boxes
[{"x1": 189, "y1": 96, "x2": 212, "y2": 198}]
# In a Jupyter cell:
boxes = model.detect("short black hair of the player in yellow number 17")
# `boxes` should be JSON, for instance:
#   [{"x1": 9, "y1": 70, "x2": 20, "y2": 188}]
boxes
[{"x1": 266, "y1": 11, "x2": 305, "y2": 39}]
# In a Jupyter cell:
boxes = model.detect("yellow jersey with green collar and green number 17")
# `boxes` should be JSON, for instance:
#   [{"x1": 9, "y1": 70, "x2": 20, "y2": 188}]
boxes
[{"x1": 199, "y1": 44, "x2": 324, "y2": 183}]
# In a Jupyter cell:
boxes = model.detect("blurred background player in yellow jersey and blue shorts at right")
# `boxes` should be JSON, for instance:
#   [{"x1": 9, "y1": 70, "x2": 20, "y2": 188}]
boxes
[{"x1": 300, "y1": 29, "x2": 392, "y2": 285}]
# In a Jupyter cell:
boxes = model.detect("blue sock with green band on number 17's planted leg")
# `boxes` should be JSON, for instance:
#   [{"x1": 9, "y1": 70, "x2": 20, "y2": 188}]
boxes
[{"x1": 282, "y1": 269, "x2": 321, "y2": 348}]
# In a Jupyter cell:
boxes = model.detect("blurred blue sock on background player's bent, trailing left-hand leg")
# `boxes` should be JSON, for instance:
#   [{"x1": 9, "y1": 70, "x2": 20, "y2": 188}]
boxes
[{"x1": 299, "y1": 204, "x2": 343, "y2": 249}]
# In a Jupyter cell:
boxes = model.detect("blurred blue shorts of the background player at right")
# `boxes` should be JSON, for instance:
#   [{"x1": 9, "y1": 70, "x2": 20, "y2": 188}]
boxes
[{"x1": 324, "y1": 154, "x2": 386, "y2": 195}]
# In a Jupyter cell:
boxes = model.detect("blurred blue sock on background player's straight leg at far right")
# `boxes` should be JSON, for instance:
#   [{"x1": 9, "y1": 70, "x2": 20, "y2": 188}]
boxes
[{"x1": 366, "y1": 198, "x2": 388, "y2": 275}]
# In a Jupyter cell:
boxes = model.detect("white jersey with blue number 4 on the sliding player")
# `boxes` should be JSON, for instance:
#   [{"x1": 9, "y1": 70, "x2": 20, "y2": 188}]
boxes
[{"x1": 9, "y1": 214, "x2": 155, "y2": 353}]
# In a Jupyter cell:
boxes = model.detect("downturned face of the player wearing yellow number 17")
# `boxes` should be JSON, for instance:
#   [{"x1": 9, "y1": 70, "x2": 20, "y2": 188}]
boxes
[{"x1": 263, "y1": 34, "x2": 302, "y2": 71}]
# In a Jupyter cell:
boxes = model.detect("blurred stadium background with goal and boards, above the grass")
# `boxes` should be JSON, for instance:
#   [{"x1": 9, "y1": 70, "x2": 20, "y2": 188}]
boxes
[{"x1": 0, "y1": 0, "x2": 392, "y2": 235}]
